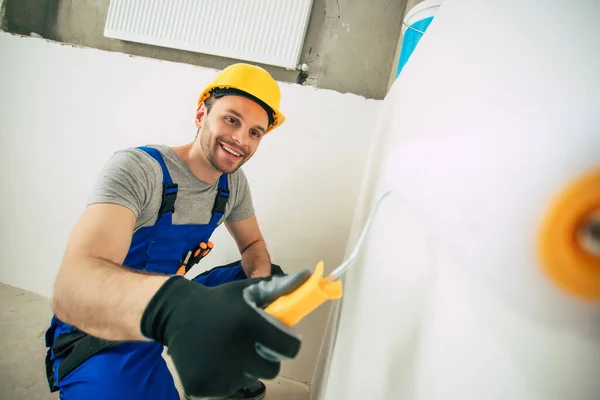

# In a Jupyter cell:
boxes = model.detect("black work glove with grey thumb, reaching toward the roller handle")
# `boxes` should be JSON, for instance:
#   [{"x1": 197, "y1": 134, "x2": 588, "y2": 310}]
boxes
[{"x1": 141, "y1": 270, "x2": 311, "y2": 397}]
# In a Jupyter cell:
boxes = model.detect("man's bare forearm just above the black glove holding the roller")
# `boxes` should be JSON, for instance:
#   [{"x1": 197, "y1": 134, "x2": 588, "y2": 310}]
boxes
[{"x1": 54, "y1": 258, "x2": 168, "y2": 340}]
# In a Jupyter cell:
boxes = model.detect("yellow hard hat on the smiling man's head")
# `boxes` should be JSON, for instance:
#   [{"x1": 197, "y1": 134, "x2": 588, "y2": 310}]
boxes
[{"x1": 198, "y1": 63, "x2": 285, "y2": 133}]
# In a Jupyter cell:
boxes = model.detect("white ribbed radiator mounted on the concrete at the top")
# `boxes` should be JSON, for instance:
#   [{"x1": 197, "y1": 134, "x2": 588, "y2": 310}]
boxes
[{"x1": 104, "y1": 0, "x2": 313, "y2": 69}]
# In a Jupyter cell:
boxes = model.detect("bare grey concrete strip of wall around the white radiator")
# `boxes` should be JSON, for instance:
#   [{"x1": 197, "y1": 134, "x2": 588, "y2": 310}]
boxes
[{"x1": 2, "y1": 0, "x2": 406, "y2": 99}]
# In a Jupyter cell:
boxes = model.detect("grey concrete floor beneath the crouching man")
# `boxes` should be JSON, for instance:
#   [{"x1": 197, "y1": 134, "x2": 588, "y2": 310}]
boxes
[{"x1": 0, "y1": 284, "x2": 309, "y2": 400}]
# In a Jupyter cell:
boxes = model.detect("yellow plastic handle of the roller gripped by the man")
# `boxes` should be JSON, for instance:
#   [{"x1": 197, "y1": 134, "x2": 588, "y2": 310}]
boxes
[{"x1": 265, "y1": 261, "x2": 342, "y2": 327}]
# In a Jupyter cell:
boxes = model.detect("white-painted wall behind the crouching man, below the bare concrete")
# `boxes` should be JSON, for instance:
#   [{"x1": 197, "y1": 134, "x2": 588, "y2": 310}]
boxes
[{"x1": 0, "y1": 33, "x2": 379, "y2": 382}]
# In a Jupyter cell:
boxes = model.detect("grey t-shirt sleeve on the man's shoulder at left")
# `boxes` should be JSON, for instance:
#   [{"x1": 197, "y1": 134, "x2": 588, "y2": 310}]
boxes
[{"x1": 87, "y1": 149, "x2": 160, "y2": 218}]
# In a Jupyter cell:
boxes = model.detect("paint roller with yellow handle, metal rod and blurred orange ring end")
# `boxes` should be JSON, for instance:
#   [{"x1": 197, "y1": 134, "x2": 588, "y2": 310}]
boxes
[{"x1": 265, "y1": 162, "x2": 600, "y2": 326}]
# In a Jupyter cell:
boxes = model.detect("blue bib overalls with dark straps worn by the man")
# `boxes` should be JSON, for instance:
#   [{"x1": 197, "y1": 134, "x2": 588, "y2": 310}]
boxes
[{"x1": 46, "y1": 147, "x2": 264, "y2": 400}]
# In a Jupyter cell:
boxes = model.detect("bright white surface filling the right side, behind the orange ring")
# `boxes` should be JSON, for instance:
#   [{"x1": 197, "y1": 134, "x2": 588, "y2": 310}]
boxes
[{"x1": 312, "y1": 0, "x2": 600, "y2": 400}]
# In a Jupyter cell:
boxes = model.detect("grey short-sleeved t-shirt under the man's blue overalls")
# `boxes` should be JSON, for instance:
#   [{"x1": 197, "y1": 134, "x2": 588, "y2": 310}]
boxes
[{"x1": 87, "y1": 145, "x2": 254, "y2": 230}]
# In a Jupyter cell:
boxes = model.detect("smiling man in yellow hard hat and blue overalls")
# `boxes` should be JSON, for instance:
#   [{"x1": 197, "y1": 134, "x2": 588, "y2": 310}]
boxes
[{"x1": 46, "y1": 64, "x2": 310, "y2": 400}]
